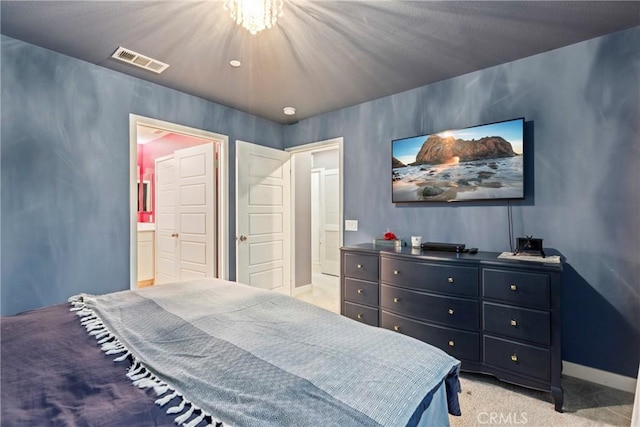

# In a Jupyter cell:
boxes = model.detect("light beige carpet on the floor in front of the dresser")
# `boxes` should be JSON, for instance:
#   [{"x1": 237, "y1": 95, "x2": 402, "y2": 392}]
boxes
[{"x1": 449, "y1": 372, "x2": 634, "y2": 427}]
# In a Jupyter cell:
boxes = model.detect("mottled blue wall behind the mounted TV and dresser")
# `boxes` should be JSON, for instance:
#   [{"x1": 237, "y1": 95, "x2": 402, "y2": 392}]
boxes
[{"x1": 284, "y1": 28, "x2": 640, "y2": 377}]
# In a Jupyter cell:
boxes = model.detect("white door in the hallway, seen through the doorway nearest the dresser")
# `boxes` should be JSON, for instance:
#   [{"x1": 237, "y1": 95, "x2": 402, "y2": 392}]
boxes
[{"x1": 320, "y1": 169, "x2": 340, "y2": 276}]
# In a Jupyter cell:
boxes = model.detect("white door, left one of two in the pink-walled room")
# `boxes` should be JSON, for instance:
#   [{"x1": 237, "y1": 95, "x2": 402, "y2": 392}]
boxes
[{"x1": 154, "y1": 155, "x2": 178, "y2": 284}]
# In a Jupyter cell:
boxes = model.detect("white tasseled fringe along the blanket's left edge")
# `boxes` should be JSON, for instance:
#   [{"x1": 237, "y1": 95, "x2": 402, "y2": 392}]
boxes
[{"x1": 68, "y1": 294, "x2": 229, "y2": 427}]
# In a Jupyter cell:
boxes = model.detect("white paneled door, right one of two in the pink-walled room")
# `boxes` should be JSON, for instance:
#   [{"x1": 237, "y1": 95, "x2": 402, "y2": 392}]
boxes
[{"x1": 174, "y1": 144, "x2": 216, "y2": 280}]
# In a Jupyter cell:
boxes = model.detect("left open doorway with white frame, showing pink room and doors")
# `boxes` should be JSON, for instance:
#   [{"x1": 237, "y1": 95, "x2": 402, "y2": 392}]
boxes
[{"x1": 129, "y1": 114, "x2": 228, "y2": 289}]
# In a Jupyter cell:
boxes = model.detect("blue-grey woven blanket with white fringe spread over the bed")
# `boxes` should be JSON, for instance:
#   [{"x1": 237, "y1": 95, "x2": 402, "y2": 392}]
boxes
[{"x1": 70, "y1": 279, "x2": 459, "y2": 427}]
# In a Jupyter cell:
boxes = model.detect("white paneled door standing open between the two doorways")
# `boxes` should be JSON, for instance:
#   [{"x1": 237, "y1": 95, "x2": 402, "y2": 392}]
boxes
[{"x1": 236, "y1": 141, "x2": 291, "y2": 295}]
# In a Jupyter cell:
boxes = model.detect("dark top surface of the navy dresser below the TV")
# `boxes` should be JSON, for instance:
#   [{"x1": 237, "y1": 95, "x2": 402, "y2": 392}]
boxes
[{"x1": 341, "y1": 243, "x2": 563, "y2": 271}]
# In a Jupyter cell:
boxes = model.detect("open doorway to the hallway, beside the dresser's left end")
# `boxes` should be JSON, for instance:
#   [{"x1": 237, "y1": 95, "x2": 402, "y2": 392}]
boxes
[{"x1": 287, "y1": 138, "x2": 343, "y2": 313}]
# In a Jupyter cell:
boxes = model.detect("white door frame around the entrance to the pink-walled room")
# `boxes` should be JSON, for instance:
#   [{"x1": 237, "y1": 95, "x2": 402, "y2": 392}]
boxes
[{"x1": 129, "y1": 114, "x2": 229, "y2": 289}]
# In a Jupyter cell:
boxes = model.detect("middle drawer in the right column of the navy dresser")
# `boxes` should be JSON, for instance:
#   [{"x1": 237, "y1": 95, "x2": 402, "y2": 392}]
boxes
[{"x1": 482, "y1": 302, "x2": 551, "y2": 345}]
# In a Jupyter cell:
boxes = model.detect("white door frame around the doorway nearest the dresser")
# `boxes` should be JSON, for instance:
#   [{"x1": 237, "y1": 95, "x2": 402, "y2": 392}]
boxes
[{"x1": 284, "y1": 137, "x2": 344, "y2": 295}]
